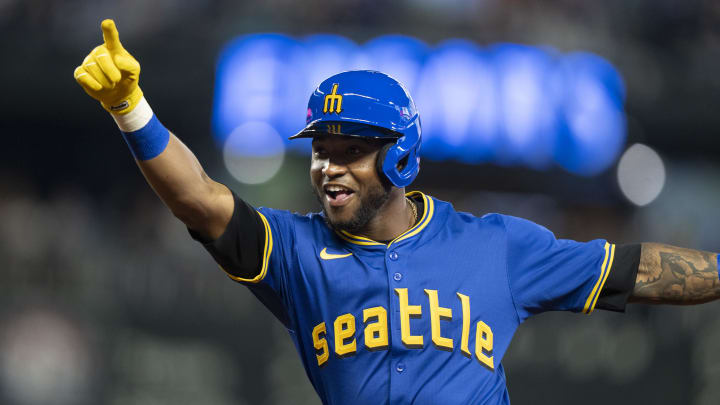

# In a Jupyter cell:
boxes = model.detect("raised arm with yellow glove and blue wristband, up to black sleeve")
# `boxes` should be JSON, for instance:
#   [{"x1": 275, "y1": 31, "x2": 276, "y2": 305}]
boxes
[{"x1": 74, "y1": 20, "x2": 235, "y2": 240}]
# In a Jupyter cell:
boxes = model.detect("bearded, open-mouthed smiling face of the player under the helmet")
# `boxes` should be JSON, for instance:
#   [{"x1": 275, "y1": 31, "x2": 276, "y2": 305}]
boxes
[{"x1": 310, "y1": 136, "x2": 390, "y2": 233}]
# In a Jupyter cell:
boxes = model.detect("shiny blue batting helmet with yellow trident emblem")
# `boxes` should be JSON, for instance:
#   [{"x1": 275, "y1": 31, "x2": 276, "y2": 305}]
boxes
[{"x1": 290, "y1": 70, "x2": 421, "y2": 187}]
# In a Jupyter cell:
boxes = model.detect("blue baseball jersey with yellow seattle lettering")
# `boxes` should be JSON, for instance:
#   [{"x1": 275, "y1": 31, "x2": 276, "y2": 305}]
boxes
[{"x1": 207, "y1": 192, "x2": 615, "y2": 405}]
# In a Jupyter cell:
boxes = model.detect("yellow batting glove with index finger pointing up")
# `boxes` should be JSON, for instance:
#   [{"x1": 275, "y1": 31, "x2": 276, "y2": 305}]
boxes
[{"x1": 74, "y1": 20, "x2": 143, "y2": 114}]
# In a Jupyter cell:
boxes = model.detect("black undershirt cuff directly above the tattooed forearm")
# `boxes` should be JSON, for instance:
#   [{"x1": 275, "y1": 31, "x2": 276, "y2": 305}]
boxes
[{"x1": 596, "y1": 243, "x2": 641, "y2": 312}]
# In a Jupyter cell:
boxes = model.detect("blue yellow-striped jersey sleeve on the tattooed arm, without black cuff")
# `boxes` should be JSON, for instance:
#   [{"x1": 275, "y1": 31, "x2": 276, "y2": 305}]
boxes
[{"x1": 502, "y1": 216, "x2": 615, "y2": 320}]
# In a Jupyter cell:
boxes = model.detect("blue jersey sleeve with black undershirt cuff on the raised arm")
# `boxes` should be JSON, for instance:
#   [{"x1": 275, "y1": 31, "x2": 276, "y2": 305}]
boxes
[{"x1": 190, "y1": 192, "x2": 295, "y2": 329}]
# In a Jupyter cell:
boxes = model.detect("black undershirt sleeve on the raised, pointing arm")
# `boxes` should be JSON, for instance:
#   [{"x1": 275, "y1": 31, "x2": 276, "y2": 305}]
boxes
[{"x1": 188, "y1": 192, "x2": 265, "y2": 279}]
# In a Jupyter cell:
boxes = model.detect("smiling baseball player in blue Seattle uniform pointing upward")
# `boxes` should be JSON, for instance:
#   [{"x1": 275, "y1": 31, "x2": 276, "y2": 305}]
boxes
[{"x1": 75, "y1": 20, "x2": 720, "y2": 404}]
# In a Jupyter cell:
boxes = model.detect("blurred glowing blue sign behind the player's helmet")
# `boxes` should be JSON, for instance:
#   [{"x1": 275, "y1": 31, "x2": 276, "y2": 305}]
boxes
[{"x1": 213, "y1": 34, "x2": 626, "y2": 175}]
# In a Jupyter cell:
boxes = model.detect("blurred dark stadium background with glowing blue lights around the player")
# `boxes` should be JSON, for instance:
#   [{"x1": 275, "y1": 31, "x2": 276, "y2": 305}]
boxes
[{"x1": 0, "y1": 0, "x2": 720, "y2": 405}]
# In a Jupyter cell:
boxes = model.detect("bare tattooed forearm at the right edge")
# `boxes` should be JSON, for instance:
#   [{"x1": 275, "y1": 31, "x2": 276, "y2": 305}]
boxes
[{"x1": 630, "y1": 243, "x2": 720, "y2": 305}]
